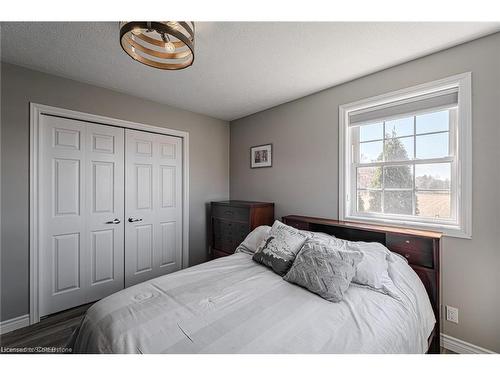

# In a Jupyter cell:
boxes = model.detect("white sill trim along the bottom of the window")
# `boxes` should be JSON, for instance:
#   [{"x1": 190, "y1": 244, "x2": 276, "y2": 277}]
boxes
[{"x1": 339, "y1": 216, "x2": 472, "y2": 240}]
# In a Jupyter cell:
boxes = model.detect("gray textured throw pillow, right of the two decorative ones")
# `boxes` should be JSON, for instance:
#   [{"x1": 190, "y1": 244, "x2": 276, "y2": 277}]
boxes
[{"x1": 283, "y1": 239, "x2": 363, "y2": 302}]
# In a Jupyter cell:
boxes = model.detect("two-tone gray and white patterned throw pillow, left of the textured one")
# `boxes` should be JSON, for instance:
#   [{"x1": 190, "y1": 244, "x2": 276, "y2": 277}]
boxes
[{"x1": 253, "y1": 220, "x2": 308, "y2": 276}]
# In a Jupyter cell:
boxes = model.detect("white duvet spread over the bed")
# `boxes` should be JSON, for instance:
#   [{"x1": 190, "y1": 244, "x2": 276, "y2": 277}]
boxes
[{"x1": 73, "y1": 253, "x2": 435, "y2": 353}]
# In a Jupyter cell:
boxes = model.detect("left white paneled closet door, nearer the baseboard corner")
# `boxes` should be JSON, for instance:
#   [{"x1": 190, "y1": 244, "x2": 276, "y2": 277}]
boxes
[{"x1": 38, "y1": 115, "x2": 124, "y2": 316}]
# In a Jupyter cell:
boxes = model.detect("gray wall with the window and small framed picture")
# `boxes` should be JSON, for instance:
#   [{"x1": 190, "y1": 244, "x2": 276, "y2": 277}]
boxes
[{"x1": 230, "y1": 33, "x2": 500, "y2": 352}]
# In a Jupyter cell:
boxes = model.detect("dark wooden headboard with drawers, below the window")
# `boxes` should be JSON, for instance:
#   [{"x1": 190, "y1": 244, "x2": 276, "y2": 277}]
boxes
[{"x1": 283, "y1": 215, "x2": 441, "y2": 354}]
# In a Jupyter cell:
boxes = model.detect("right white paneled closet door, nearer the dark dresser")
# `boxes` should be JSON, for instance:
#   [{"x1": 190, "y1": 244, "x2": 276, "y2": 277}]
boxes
[{"x1": 125, "y1": 130, "x2": 182, "y2": 287}]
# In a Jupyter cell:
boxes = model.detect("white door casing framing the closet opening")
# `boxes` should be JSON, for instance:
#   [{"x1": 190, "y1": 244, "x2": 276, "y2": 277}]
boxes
[{"x1": 29, "y1": 103, "x2": 189, "y2": 324}]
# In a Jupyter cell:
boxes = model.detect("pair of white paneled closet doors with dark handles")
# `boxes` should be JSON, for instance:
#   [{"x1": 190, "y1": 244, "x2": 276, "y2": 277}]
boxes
[{"x1": 38, "y1": 115, "x2": 183, "y2": 316}]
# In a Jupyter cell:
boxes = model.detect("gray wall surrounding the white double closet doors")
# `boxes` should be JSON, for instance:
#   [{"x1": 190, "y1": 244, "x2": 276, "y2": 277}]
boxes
[{"x1": 0, "y1": 64, "x2": 229, "y2": 321}]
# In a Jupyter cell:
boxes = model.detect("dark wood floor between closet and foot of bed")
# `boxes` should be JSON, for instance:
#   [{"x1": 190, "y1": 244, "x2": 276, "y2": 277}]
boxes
[{"x1": 0, "y1": 303, "x2": 92, "y2": 353}]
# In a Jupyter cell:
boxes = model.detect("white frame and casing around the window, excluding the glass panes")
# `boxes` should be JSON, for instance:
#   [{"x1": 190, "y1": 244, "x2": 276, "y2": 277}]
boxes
[{"x1": 339, "y1": 72, "x2": 472, "y2": 239}]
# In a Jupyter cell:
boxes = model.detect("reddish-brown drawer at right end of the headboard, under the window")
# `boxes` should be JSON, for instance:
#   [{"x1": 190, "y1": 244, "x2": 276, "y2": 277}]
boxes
[{"x1": 386, "y1": 234, "x2": 434, "y2": 268}]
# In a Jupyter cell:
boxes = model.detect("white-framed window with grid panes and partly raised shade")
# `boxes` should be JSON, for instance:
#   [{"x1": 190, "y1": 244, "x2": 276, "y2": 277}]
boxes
[{"x1": 339, "y1": 73, "x2": 471, "y2": 238}]
